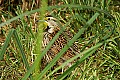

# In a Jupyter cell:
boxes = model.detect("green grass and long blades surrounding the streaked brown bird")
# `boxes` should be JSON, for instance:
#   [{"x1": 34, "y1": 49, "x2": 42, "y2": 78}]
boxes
[{"x1": 0, "y1": 0, "x2": 120, "y2": 80}]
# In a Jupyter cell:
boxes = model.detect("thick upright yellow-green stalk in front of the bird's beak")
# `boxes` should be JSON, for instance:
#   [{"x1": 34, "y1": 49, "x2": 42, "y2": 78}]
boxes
[{"x1": 35, "y1": 0, "x2": 47, "y2": 79}]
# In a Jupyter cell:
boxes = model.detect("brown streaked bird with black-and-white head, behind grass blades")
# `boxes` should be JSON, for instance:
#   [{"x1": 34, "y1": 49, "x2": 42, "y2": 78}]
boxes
[{"x1": 41, "y1": 16, "x2": 79, "y2": 73}]
